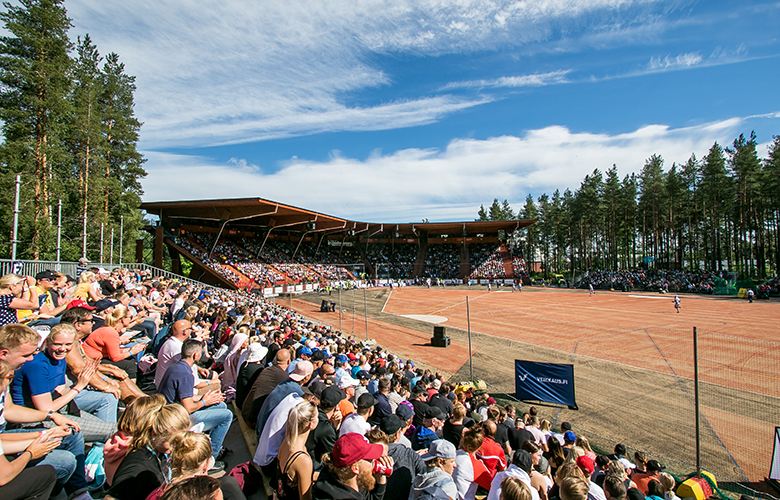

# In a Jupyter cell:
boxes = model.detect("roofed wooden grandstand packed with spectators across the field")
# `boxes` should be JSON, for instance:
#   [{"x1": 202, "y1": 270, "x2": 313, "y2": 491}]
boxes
[{"x1": 141, "y1": 198, "x2": 535, "y2": 290}]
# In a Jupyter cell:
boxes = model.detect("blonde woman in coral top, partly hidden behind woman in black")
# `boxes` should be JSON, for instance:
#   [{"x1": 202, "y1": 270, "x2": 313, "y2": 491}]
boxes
[{"x1": 103, "y1": 394, "x2": 165, "y2": 486}]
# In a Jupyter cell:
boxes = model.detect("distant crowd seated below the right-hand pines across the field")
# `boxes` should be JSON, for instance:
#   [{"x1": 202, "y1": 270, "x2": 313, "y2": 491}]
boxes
[{"x1": 576, "y1": 269, "x2": 724, "y2": 294}]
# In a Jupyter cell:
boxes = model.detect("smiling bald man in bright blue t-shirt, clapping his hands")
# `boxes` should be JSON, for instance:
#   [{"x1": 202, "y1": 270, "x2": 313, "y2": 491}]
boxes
[{"x1": 11, "y1": 323, "x2": 118, "y2": 443}]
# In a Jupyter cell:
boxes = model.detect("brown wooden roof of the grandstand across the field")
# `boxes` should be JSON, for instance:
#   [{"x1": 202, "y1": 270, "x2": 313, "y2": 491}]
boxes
[{"x1": 141, "y1": 198, "x2": 536, "y2": 237}]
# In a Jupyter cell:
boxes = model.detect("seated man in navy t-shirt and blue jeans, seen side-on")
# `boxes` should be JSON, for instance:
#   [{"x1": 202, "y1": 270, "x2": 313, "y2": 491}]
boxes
[{"x1": 157, "y1": 339, "x2": 233, "y2": 468}]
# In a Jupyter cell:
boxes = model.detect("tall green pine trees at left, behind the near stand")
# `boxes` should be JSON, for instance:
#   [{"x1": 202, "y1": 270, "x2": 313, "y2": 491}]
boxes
[{"x1": 0, "y1": 0, "x2": 146, "y2": 261}]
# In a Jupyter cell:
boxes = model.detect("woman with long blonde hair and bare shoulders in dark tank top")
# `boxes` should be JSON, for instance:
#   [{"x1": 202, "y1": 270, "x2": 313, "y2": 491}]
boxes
[{"x1": 274, "y1": 401, "x2": 319, "y2": 500}]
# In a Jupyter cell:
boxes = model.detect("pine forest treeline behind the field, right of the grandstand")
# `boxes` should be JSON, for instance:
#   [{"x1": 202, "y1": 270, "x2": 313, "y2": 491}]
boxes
[{"x1": 476, "y1": 133, "x2": 780, "y2": 278}]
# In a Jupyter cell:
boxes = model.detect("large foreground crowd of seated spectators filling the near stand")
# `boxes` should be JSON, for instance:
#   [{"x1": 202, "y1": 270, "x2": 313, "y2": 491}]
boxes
[{"x1": 0, "y1": 269, "x2": 676, "y2": 500}]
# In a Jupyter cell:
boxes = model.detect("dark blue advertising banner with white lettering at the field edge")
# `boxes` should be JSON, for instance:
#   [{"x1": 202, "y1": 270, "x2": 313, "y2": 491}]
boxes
[{"x1": 515, "y1": 359, "x2": 577, "y2": 410}]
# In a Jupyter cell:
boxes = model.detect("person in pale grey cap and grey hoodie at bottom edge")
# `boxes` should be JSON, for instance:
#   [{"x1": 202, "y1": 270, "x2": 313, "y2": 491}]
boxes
[{"x1": 409, "y1": 439, "x2": 458, "y2": 500}]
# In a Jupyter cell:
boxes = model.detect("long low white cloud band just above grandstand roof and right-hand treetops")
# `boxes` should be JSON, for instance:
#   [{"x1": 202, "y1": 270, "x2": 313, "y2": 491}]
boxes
[{"x1": 144, "y1": 114, "x2": 778, "y2": 222}]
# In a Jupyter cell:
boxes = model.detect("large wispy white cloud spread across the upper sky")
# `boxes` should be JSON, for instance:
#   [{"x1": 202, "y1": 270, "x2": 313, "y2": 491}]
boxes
[{"x1": 67, "y1": 0, "x2": 661, "y2": 148}]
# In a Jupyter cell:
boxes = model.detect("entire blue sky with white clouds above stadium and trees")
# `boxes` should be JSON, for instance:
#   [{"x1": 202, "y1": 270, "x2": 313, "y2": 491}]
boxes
[{"x1": 65, "y1": 0, "x2": 780, "y2": 222}]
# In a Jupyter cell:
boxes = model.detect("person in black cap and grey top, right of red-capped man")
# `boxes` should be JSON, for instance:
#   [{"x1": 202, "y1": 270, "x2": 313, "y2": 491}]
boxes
[{"x1": 379, "y1": 416, "x2": 427, "y2": 499}]
